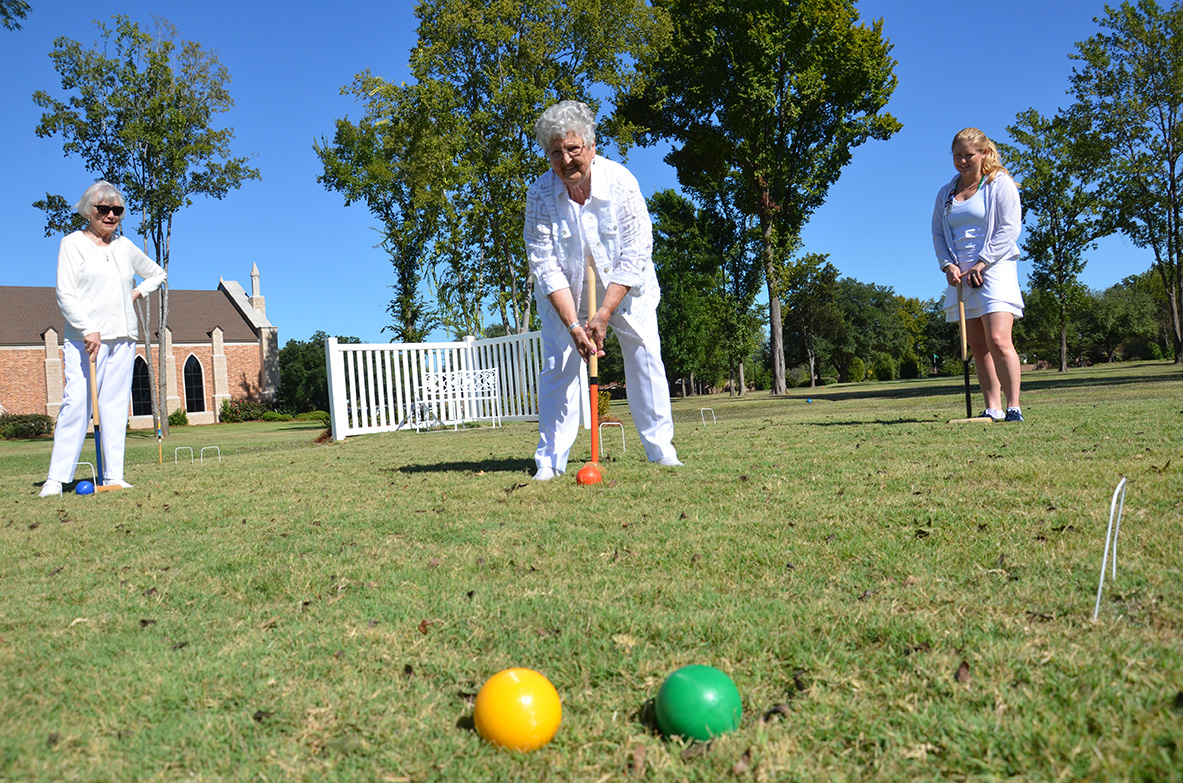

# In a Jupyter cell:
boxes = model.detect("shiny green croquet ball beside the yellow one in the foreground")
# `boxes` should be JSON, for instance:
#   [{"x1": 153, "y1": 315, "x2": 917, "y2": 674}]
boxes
[{"x1": 654, "y1": 666, "x2": 743, "y2": 742}]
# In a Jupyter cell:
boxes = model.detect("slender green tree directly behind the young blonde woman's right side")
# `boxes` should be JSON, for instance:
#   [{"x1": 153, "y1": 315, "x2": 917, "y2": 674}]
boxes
[{"x1": 1000, "y1": 109, "x2": 1113, "y2": 373}]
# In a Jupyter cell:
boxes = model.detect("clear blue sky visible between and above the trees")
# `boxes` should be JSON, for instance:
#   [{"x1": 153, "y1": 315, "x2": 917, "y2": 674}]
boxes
[{"x1": 0, "y1": 0, "x2": 1152, "y2": 342}]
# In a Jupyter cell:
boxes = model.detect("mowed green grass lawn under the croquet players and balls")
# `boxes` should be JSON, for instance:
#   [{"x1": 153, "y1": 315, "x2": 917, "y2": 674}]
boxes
[{"x1": 0, "y1": 363, "x2": 1183, "y2": 782}]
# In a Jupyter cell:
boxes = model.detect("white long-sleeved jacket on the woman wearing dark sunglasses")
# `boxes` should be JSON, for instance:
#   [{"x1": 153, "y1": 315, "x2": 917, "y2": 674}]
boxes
[{"x1": 57, "y1": 231, "x2": 164, "y2": 339}]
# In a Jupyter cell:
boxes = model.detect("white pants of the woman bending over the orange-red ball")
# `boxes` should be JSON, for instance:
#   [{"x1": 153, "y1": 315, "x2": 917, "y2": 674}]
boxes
[{"x1": 534, "y1": 292, "x2": 678, "y2": 473}]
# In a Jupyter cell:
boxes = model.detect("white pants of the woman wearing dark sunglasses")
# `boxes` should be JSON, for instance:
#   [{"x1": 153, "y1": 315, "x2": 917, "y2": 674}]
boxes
[{"x1": 50, "y1": 339, "x2": 136, "y2": 484}]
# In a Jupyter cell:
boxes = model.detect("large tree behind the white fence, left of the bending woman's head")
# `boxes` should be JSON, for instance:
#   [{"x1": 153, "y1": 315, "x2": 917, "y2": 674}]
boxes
[{"x1": 318, "y1": 0, "x2": 664, "y2": 335}]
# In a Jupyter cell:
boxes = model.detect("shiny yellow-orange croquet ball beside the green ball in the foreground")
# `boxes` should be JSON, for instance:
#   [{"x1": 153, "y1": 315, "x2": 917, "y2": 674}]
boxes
[{"x1": 472, "y1": 668, "x2": 563, "y2": 752}]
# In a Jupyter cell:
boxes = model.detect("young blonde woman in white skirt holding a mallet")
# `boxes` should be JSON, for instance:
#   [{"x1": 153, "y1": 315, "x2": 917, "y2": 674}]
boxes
[{"x1": 932, "y1": 128, "x2": 1023, "y2": 421}]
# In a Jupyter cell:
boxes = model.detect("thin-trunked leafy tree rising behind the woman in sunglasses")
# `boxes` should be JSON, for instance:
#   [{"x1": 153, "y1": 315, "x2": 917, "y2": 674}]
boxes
[{"x1": 33, "y1": 15, "x2": 259, "y2": 432}]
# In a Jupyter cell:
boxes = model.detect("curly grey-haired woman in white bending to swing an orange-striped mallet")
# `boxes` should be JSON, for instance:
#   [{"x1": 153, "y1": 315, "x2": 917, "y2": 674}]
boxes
[{"x1": 525, "y1": 101, "x2": 681, "y2": 481}]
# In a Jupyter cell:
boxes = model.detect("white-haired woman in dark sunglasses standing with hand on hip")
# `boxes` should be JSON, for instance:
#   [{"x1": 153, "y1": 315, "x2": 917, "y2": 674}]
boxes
[{"x1": 41, "y1": 181, "x2": 164, "y2": 498}]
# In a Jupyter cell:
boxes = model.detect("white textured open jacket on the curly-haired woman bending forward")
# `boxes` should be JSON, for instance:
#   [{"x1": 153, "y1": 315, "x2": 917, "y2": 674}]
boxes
[{"x1": 524, "y1": 156, "x2": 661, "y2": 311}]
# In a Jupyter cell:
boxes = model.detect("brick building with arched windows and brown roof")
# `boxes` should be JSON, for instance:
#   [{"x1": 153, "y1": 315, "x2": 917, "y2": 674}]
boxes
[{"x1": 0, "y1": 266, "x2": 279, "y2": 429}]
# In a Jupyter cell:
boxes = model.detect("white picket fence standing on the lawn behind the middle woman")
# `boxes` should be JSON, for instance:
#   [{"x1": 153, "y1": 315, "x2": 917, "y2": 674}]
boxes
[{"x1": 324, "y1": 331, "x2": 590, "y2": 440}]
